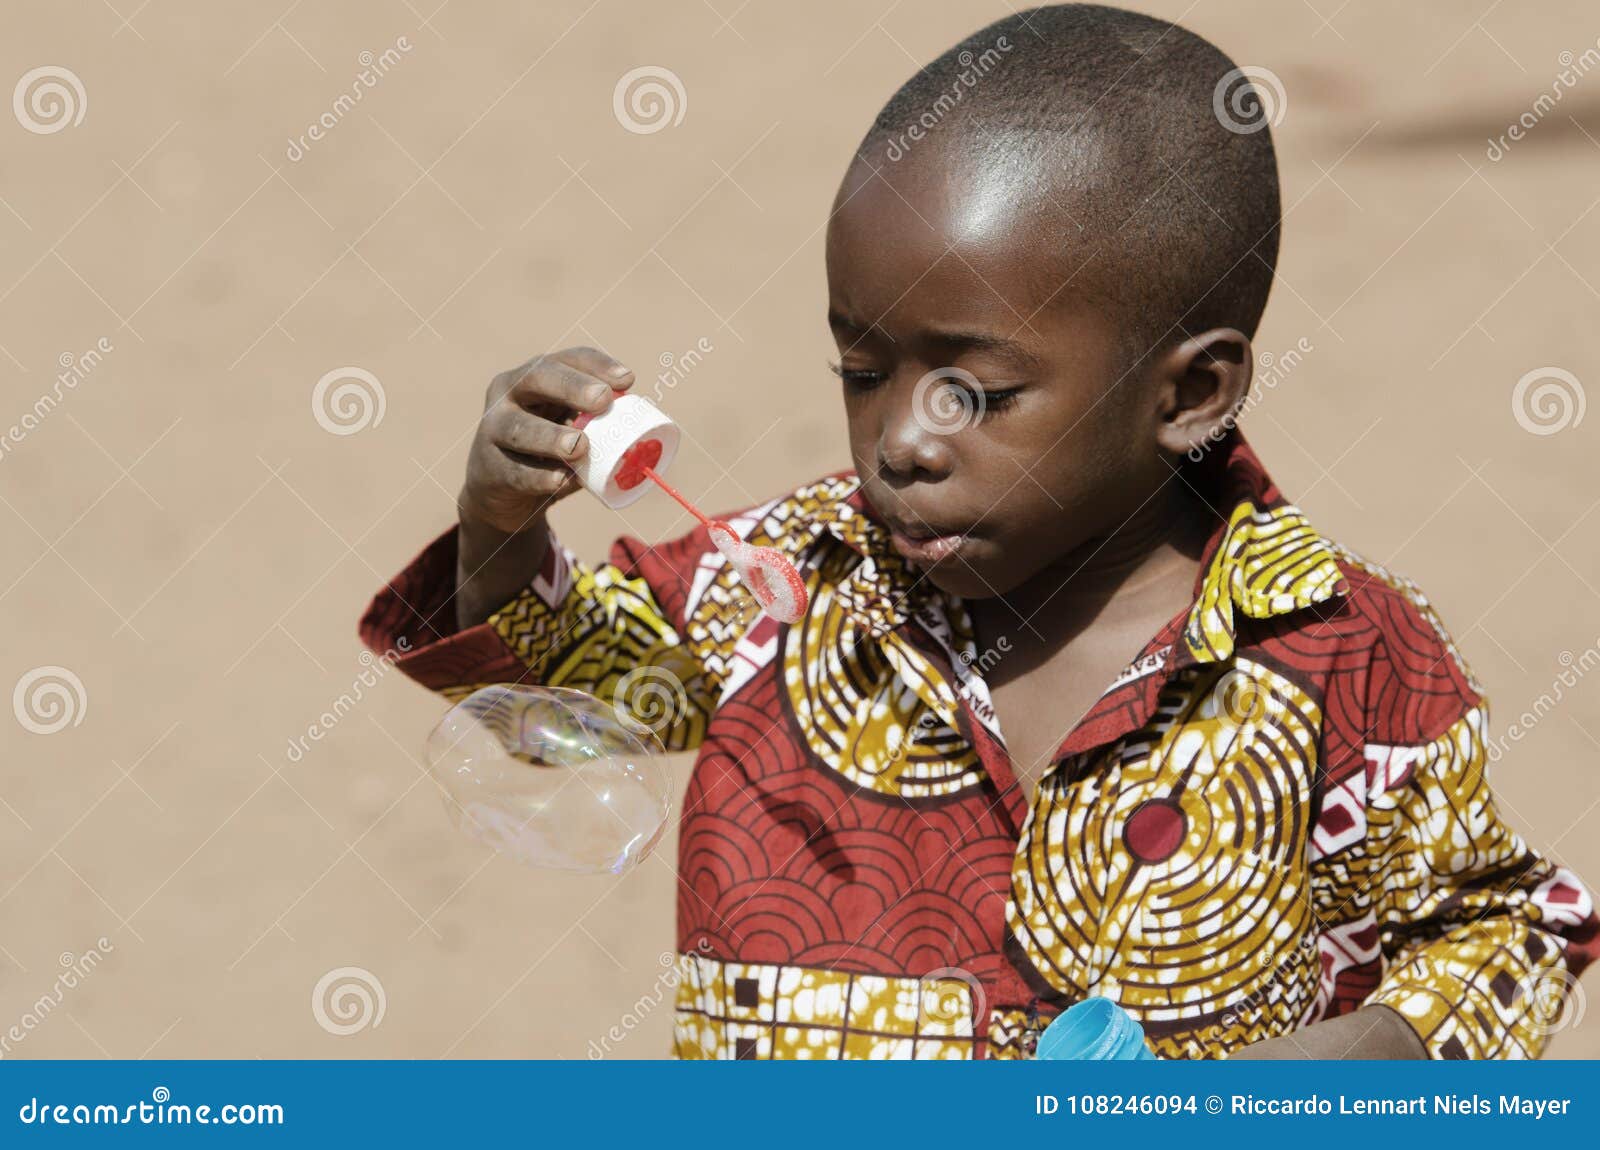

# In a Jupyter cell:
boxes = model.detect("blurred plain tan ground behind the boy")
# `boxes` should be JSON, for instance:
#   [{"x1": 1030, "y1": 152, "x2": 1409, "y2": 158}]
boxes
[{"x1": 0, "y1": 0, "x2": 1600, "y2": 1057}]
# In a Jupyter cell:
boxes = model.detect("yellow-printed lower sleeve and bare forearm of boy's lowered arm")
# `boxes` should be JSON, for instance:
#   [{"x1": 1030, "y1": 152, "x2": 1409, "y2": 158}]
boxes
[{"x1": 1230, "y1": 699, "x2": 1600, "y2": 1059}]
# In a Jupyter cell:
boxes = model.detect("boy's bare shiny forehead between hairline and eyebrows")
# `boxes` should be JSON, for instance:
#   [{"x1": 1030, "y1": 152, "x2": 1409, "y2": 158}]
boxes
[{"x1": 827, "y1": 142, "x2": 1093, "y2": 325}]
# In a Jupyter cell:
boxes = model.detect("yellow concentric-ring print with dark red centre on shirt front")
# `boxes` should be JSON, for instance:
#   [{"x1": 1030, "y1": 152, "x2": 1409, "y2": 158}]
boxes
[{"x1": 1006, "y1": 659, "x2": 1322, "y2": 1054}]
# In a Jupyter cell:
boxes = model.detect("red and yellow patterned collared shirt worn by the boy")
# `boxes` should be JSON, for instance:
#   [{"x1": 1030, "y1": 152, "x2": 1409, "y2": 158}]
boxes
[{"x1": 362, "y1": 433, "x2": 1600, "y2": 1059}]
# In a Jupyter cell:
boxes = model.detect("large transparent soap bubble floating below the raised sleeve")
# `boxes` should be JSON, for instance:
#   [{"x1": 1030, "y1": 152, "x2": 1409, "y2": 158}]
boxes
[{"x1": 427, "y1": 686, "x2": 672, "y2": 875}]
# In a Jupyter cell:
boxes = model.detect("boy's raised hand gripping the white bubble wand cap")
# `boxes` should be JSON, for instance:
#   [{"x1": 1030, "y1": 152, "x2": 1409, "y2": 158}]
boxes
[{"x1": 456, "y1": 347, "x2": 634, "y2": 534}]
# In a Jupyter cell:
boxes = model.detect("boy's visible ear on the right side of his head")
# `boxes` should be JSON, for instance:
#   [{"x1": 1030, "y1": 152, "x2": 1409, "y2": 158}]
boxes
[{"x1": 1155, "y1": 328, "x2": 1254, "y2": 454}]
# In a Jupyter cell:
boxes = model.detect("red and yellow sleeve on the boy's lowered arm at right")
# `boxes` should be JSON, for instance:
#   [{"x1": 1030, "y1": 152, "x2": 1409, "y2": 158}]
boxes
[{"x1": 1365, "y1": 581, "x2": 1600, "y2": 1059}]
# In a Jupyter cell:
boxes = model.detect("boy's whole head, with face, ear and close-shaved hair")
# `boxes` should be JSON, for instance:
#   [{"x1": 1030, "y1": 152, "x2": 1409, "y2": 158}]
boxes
[{"x1": 827, "y1": 5, "x2": 1278, "y2": 609}]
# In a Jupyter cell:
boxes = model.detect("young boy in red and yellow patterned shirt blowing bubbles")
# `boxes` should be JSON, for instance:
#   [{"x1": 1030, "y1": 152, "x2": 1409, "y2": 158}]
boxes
[{"x1": 362, "y1": 5, "x2": 1600, "y2": 1057}]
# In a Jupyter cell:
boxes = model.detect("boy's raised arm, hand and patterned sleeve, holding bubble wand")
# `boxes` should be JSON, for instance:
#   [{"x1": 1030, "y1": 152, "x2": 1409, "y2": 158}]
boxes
[{"x1": 362, "y1": 347, "x2": 715, "y2": 750}]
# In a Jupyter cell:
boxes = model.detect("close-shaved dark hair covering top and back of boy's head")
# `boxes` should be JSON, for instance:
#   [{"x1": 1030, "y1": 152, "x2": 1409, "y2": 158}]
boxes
[{"x1": 859, "y1": 3, "x2": 1280, "y2": 358}]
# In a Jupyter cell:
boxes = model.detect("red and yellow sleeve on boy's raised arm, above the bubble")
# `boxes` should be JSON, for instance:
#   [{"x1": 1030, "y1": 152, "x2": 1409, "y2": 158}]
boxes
[{"x1": 360, "y1": 528, "x2": 715, "y2": 750}]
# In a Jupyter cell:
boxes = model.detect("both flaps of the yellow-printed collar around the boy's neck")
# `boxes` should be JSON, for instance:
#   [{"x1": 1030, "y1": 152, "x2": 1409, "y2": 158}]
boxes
[{"x1": 808, "y1": 429, "x2": 1349, "y2": 662}]
